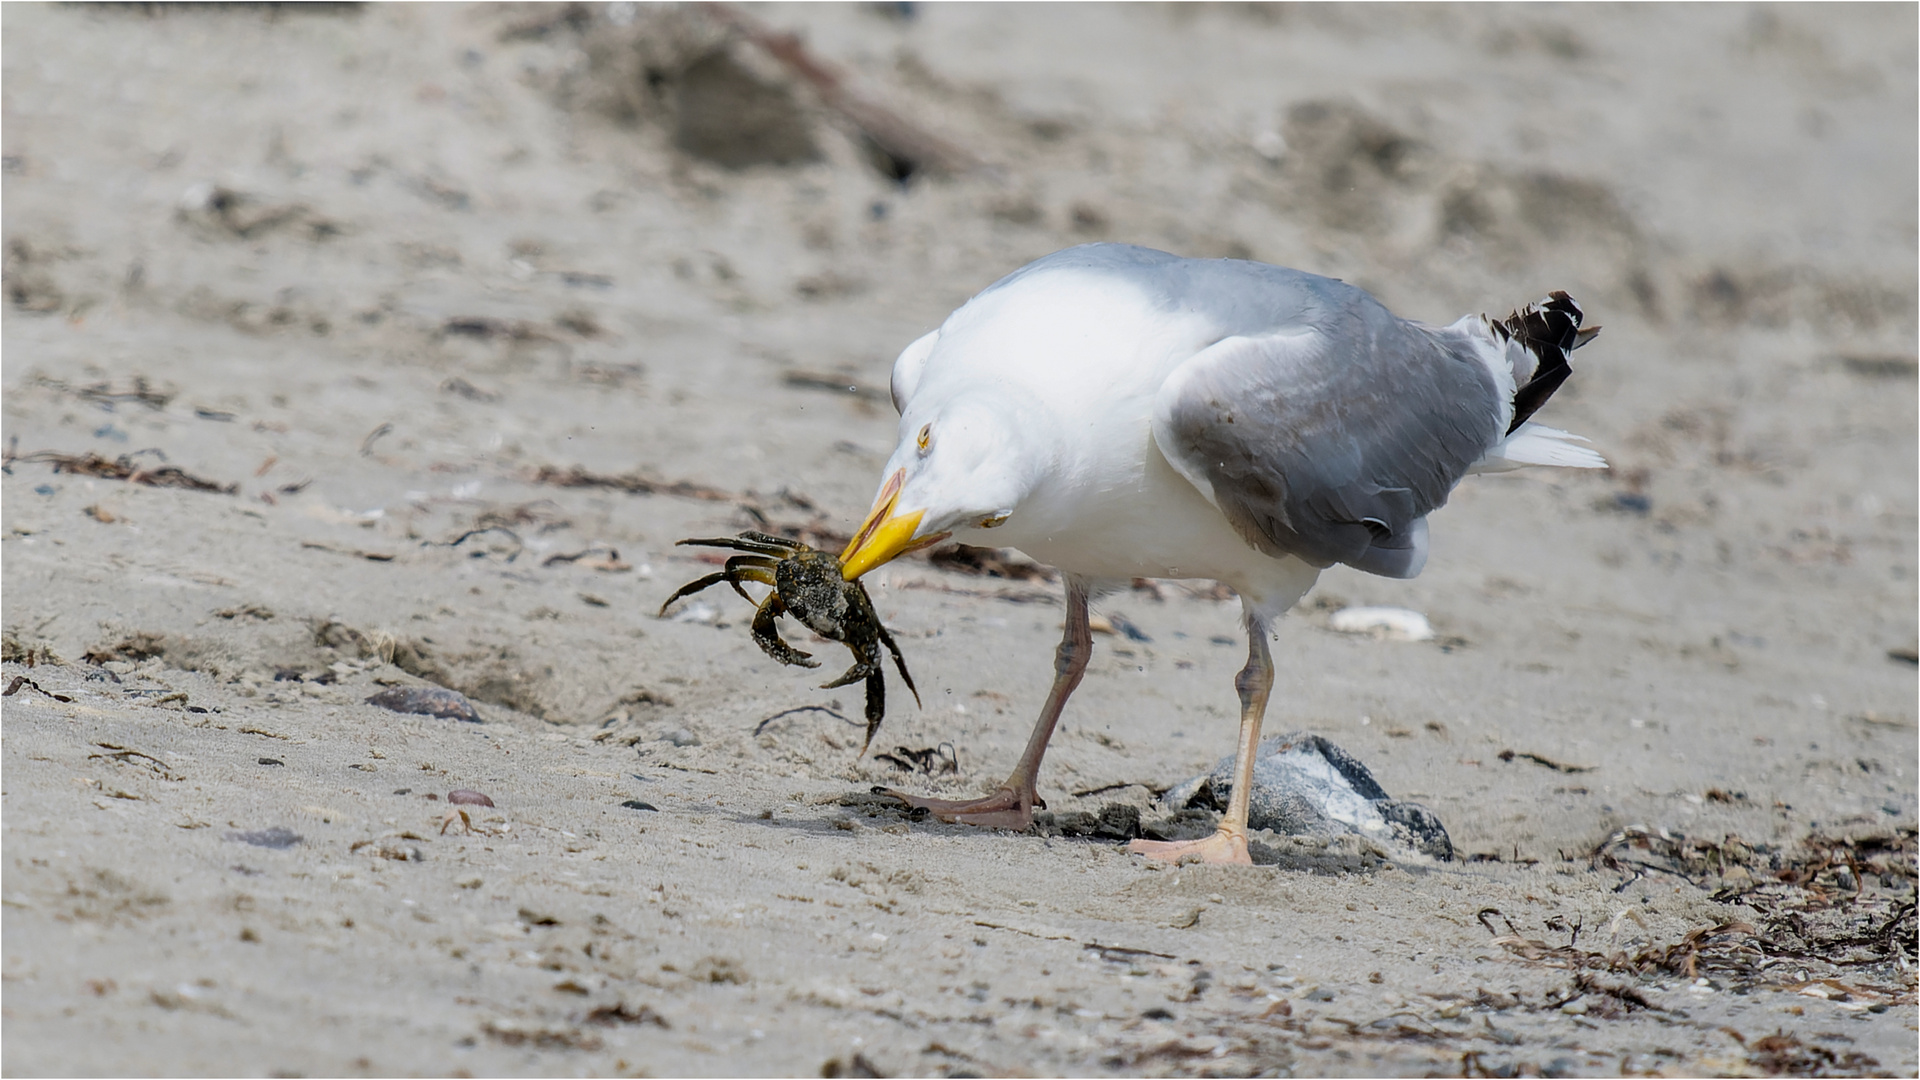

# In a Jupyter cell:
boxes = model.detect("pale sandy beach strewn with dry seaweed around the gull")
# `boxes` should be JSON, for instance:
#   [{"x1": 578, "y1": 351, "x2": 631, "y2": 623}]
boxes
[{"x1": 0, "y1": 4, "x2": 1920, "y2": 1076}]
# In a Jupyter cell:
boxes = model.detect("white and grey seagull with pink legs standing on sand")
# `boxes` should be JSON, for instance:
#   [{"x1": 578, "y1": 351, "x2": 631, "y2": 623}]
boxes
[{"x1": 841, "y1": 244, "x2": 1607, "y2": 863}]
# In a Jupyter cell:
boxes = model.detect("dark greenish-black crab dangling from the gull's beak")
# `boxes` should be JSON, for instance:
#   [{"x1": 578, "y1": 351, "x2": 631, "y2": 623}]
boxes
[{"x1": 660, "y1": 532, "x2": 920, "y2": 755}]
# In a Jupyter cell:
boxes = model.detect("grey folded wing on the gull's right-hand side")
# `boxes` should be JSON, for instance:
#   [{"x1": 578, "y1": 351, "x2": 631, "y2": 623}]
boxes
[{"x1": 1154, "y1": 294, "x2": 1503, "y2": 577}]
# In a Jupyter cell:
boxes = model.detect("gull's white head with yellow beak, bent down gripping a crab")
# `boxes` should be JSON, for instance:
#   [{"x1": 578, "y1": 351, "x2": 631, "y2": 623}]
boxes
[{"x1": 841, "y1": 396, "x2": 1044, "y2": 580}]
